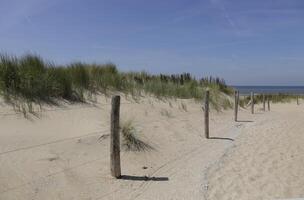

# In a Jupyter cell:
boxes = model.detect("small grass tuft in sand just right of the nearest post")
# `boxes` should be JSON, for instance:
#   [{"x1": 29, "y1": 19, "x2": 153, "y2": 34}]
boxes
[{"x1": 121, "y1": 120, "x2": 153, "y2": 151}]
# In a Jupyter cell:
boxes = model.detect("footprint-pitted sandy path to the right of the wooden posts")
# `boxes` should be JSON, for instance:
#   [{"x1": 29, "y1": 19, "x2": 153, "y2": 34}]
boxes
[{"x1": 207, "y1": 104, "x2": 304, "y2": 200}]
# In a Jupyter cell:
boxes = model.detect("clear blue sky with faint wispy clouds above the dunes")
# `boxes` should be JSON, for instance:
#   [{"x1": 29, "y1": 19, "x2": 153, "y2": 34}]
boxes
[{"x1": 0, "y1": 0, "x2": 304, "y2": 85}]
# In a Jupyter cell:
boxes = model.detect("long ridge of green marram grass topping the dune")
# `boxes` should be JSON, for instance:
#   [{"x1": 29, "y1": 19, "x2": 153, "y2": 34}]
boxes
[{"x1": 0, "y1": 54, "x2": 233, "y2": 108}]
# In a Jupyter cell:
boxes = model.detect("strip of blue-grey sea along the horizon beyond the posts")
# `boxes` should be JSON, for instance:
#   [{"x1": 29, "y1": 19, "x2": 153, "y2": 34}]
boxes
[{"x1": 232, "y1": 86, "x2": 304, "y2": 95}]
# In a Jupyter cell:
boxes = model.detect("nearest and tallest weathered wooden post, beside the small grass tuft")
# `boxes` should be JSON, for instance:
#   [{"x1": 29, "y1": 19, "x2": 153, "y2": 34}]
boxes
[{"x1": 110, "y1": 95, "x2": 121, "y2": 178}]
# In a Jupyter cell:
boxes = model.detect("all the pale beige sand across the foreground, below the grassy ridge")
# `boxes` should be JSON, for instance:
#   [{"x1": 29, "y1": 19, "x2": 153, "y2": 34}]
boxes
[{"x1": 0, "y1": 96, "x2": 304, "y2": 200}]
